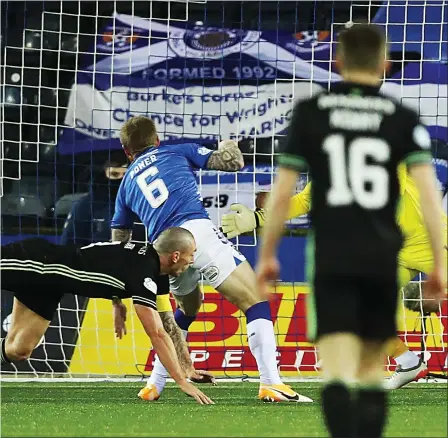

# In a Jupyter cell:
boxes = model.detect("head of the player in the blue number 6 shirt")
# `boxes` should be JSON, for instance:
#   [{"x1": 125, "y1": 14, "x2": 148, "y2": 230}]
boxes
[{"x1": 120, "y1": 116, "x2": 160, "y2": 161}]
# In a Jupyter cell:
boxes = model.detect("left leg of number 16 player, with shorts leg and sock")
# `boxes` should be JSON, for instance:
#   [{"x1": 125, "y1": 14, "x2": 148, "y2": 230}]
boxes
[{"x1": 314, "y1": 275, "x2": 361, "y2": 437}]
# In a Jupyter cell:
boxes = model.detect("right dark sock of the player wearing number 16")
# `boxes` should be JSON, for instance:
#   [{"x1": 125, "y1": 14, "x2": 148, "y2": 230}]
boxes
[{"x1": 356, "y1": 387, "x2": 387, "y2": 438}]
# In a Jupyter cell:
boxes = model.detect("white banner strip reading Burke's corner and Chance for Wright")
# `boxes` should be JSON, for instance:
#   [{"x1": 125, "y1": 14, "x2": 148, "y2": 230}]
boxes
[{"x1": 66, "y1": 82, "x2": 322, "y2": 140}]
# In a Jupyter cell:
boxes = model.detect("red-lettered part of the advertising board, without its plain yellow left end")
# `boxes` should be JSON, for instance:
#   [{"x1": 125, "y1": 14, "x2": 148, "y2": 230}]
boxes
[{"x1": 145, "y1": 285, "x2": 448, "y2": 377}]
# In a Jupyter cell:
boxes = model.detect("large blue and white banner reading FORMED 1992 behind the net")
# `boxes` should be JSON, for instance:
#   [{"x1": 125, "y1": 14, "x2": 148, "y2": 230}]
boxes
[{"x1": 59, "y1": 6, "x2": 448, "y2": 154}]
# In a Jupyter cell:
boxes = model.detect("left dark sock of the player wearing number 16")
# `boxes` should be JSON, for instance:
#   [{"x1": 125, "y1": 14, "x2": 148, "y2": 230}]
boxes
[{"x1": 322, "y1": 382, "x2": 355, "y2": 438}]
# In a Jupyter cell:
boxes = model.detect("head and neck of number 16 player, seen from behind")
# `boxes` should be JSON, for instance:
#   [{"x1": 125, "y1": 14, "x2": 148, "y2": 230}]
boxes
[{"x1": 336, "y1": 24, "x2": 389, "y2": 82}]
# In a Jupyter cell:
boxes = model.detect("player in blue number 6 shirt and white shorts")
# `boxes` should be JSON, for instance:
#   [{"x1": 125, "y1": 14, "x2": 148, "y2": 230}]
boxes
[{"x1": 112, "y1": 116, "x2": 312, "y2": 402}]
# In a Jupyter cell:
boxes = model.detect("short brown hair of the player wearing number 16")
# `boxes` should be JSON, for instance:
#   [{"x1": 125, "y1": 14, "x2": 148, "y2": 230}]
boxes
[{"x1": 337, "y1": 24, "x2": 388, "y2": 72}]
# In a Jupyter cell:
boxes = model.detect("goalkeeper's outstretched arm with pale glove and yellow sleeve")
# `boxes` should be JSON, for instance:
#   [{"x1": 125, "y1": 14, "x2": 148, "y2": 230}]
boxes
[{"x1": 221, "y1": 183, "x2": 311, "y2": 239}]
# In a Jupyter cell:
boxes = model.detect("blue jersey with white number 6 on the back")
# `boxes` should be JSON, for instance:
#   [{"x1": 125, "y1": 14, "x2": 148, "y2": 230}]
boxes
[{"x1": 112, "y1": 143, "x2": 213, "y2": 242}]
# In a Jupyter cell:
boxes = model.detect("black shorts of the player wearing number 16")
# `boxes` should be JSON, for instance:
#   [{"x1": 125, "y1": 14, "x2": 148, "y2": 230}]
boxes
[{"x1": 307, "y1": 274, "x2": 398, "y2": 341}]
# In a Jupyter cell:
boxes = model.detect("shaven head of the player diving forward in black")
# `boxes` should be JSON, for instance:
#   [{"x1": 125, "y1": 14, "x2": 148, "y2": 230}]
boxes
[{"x1": 154, "y1": 227, "x2": 196, "y2": 277}]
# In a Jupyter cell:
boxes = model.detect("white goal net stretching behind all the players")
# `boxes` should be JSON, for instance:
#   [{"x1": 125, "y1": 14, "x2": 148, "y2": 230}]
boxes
[{"x1": 0, "y1": 1, "x2": 448, "y2": 379}]
